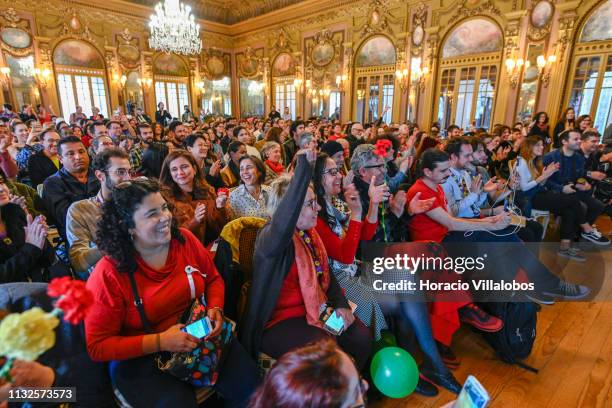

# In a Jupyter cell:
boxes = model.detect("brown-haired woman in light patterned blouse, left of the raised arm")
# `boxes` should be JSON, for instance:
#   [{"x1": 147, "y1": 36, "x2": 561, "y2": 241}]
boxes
[{"x1": 229, "y1": 156, "x2": 270, "y2": 218}]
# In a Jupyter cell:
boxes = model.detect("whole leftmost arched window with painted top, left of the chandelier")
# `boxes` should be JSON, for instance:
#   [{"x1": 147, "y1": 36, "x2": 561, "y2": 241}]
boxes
[{"x1": 53, "y1": 40, "x2": 109, "y2": 120}]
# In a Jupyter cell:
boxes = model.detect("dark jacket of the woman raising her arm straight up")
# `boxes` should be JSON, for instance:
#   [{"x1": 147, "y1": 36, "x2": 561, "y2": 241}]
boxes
[{"x1": 240, "y1": 155, "x2": 349, "y2": 357}]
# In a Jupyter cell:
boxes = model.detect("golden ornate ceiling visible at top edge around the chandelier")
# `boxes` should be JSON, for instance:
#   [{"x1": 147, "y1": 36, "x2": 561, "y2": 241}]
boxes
[{"x1": 128, "y1": 0, "x2": 304, "y2": 24}]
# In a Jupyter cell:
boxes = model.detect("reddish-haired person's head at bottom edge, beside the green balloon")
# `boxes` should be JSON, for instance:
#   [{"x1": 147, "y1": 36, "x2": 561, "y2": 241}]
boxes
[{"x1": 249, "y1": 341, "x2": 368, "y2": 408}]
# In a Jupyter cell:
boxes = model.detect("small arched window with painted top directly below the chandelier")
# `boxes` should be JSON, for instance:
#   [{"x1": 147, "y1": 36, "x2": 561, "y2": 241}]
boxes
[{"x1": 153, "y1": 53, "x2": 189, "y2": 118}]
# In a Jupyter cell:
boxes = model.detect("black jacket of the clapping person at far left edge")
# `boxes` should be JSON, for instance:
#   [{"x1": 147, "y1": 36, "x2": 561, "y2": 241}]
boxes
[{"x1": 0, "y1": 204, "x2": 55, "y2": 283}]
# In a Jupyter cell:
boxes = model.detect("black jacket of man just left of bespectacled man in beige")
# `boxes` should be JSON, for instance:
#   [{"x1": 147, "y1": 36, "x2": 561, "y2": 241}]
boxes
[{"x1": 42, "y1": 168, "x2": 100, "y2": 241}]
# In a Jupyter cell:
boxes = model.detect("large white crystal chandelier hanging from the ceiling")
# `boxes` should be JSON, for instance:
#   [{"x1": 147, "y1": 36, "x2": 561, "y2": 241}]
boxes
[{"x1": 149, "y1": 0, "x2": 202, "y2": 55}]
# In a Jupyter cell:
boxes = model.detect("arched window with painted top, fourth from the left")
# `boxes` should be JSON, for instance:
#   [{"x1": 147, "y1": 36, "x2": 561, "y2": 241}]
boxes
[{"x1": 354, "y1": 35, "x2": 397, "y2": 123}]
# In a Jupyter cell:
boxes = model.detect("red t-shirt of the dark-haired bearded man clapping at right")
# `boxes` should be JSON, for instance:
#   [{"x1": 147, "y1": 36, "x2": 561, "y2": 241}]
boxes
[{"x1": 406, "y1": 179, "x2": 448, "y2": 242}]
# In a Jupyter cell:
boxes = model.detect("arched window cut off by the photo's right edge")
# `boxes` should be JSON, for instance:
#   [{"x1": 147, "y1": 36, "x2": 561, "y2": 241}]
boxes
[{"x1": 568, "y1": 0, "x2": 612, "y2": 134}]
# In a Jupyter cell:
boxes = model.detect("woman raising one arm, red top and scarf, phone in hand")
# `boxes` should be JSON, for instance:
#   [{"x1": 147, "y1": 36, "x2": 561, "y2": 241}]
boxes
[{"x1": 241, "y1": 149, "x2": 371, "y2": 369}]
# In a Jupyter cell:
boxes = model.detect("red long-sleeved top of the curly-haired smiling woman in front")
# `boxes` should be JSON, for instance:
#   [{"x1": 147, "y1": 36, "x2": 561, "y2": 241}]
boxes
[{"x1": 85, "y1": 228, "x2": 225, "y2": 361}]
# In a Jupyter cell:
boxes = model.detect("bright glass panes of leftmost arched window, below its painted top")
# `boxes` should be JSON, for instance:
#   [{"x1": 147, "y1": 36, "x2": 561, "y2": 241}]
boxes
[{"x1": 57, "y1": 74, "x2": 108, "y2": 119}]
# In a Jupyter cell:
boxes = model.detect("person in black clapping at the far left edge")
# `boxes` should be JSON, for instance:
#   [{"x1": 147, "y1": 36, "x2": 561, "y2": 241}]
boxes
[{"x1": 0, "y1": 177, "x2": 55, "y2": 283}]
